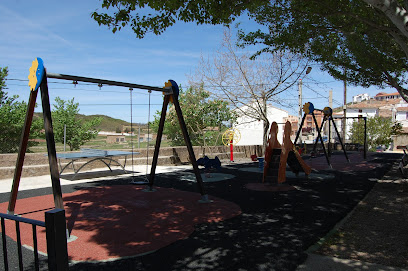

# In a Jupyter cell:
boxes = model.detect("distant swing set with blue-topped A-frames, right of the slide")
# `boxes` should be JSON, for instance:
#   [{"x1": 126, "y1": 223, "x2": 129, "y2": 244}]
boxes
[{"x1": 294, "y1": 102, "x2": 367, "y2": 168}]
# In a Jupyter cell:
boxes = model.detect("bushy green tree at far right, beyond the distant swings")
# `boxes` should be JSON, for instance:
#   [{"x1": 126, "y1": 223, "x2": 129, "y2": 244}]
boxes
[{"x1": 350, "y1": 116, "x2": 402, "y2": 151}]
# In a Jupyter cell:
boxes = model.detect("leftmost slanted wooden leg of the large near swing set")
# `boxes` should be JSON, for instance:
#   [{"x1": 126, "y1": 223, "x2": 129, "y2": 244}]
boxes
[{"x1": 7, "y1": 90, "x2": 38, "y2": 215}]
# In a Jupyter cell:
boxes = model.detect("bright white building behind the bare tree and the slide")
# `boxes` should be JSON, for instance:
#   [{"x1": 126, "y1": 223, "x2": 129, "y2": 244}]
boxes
[{"x1": 234, "y1": 105, "x2": 289, "y2": 146}]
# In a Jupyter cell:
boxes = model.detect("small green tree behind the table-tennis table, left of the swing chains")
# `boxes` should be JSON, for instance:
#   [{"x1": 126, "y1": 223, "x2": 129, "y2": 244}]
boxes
[{"x1": 52, "y1": 97, "x2": 102, "y2": 151}]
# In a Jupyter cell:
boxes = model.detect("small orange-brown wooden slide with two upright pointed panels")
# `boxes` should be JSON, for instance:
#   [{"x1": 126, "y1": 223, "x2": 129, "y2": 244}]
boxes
[{"x1": 262, "y1": 121, "x2": 312, "y2": 184}]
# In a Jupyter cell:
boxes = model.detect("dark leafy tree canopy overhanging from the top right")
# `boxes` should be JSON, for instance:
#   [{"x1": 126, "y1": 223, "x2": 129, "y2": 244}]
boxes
[{"x1": 92, "y1": 0, "x2": 408, "y2": 101}]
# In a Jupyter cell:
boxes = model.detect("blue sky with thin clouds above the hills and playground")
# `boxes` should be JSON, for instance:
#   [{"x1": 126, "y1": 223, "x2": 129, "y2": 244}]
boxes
[{"x1": 0, "y1": 0, "x2": 395, "y2": 123}]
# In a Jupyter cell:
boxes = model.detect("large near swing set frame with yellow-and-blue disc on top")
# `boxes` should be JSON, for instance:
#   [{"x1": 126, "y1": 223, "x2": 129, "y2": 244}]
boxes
[{"x1": 7, "y1": 58, "x2": 210, "y2": 215}]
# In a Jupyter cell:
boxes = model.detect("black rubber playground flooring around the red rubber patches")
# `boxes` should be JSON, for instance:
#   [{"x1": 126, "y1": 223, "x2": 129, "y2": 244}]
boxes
[{"x1": 0, "y1": 153, "x2": 401, "y2": 271}]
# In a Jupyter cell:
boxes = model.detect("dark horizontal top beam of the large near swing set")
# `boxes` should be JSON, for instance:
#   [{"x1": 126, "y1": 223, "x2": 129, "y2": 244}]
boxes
[{"x1": 47, "y1": 73, "x2": 172, "y2": 94}]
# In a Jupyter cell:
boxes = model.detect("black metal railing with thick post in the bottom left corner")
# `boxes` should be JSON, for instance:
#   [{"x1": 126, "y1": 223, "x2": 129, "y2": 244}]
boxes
[{"x1": 0, "y1": 209, "x2": 69, "y2": 271}]
